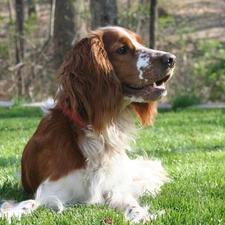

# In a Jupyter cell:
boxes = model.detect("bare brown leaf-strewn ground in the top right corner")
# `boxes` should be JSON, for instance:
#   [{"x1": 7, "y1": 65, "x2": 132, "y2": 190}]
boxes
[{"x1": 162, "y1": 0, "x2": 225, "y2": 41}]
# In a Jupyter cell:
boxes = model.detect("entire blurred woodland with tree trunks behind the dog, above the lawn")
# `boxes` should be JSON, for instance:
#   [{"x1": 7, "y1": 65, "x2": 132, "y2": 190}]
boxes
[{"x1": 0, "y1": 0, "x2": 225, "y2": 103}]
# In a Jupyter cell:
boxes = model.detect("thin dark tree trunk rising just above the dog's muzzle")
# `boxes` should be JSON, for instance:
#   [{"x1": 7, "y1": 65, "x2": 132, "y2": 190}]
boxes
[{"x1": 150, "y1": 0, "x2": 158, "y2": 49}]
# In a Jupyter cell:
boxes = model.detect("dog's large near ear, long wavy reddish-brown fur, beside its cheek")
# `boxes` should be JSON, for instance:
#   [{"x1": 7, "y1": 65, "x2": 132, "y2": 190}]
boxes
[{"x1": 56, "y1": 33, "x2": 122, "y2": 133}]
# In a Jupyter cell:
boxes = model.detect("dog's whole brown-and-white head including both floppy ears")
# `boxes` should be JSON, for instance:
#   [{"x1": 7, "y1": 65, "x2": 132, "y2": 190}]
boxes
[{"x1": 57, "y1": 27, "x2": 176, "y2": 131}]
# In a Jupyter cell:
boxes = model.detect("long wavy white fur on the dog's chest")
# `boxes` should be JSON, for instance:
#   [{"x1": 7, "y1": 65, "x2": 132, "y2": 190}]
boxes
[{"x1": 78, "y1": 130, "x2": 131, "y2": 203}]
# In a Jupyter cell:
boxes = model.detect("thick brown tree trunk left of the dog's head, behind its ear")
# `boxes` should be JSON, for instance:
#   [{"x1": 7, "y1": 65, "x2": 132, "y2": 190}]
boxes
[{"x1": 54, "y1": 0, "x2": 75, "y2": 70}]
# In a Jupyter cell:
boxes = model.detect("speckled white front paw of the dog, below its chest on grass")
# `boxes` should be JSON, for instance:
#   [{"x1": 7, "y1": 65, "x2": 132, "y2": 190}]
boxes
[{"x1": 126, "y1": 206, "x2": 156, "y2": 223}]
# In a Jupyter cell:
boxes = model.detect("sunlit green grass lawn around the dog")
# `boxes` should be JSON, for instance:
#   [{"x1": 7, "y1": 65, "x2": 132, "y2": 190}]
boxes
[{"x1": 0, "y1": 107, "x2": 225, "y2": 225}]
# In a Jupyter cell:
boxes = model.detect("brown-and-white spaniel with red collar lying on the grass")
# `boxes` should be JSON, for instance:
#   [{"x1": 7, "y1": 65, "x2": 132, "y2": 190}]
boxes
[{"x1": 2, "y1": 27, "x2": 176, "y2": 223}]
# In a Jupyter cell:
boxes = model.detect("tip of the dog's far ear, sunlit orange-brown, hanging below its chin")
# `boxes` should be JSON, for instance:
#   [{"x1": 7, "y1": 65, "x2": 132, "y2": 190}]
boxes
[{"x1": 132, "y1": 102, "x2": 157, "y2": 125}]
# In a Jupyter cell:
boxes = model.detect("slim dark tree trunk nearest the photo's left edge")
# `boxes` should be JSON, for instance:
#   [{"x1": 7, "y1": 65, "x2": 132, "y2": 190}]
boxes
[{"x1": 15, "y1": 0, "x2": 24, "y2": 97}]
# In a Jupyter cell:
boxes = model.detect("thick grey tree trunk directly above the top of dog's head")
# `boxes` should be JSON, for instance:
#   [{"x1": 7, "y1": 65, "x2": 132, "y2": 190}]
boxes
[{"x1": 90, "y1": 0, "x2": 117, "y2": 29}]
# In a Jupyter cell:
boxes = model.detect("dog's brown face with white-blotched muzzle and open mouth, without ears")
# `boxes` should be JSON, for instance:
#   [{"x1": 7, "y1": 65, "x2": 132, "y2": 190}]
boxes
[{"x1": 98, "y1": 27, "x2": 176, "y2": 103}]
